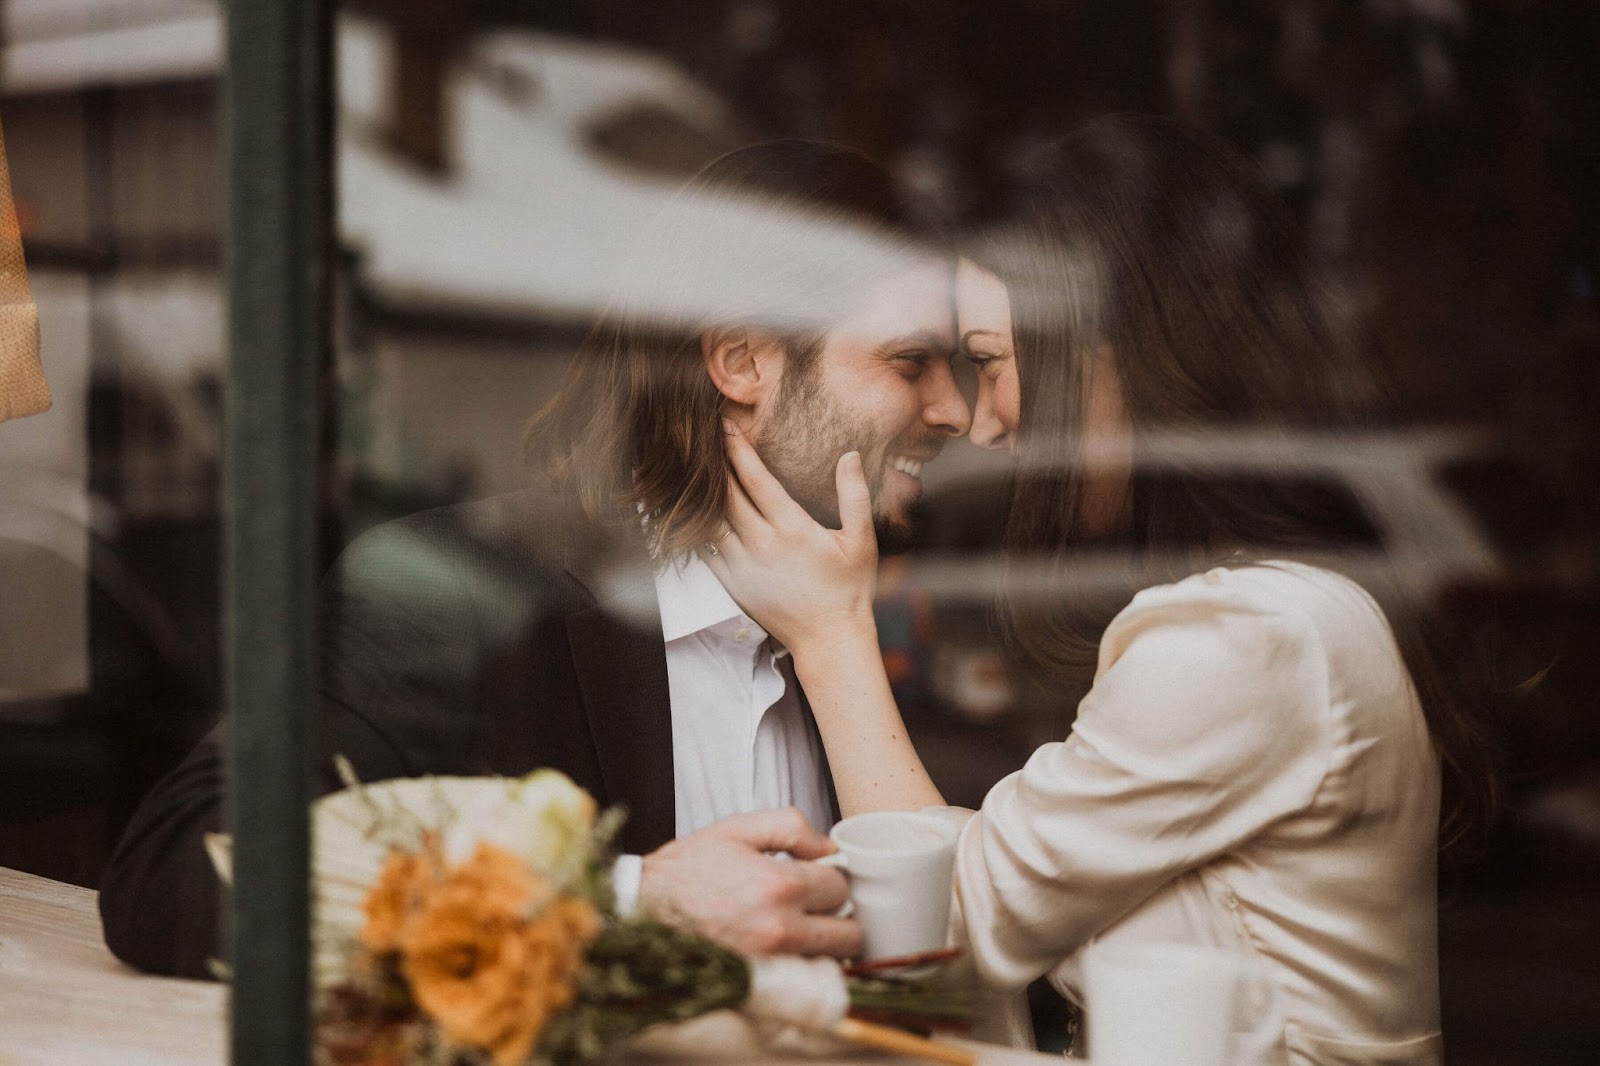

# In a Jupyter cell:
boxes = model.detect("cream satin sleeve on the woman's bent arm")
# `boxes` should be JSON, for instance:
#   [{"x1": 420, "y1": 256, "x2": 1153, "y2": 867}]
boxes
[{"x1": 957, "y1": 573, "x2": 1331, "y2": 988}]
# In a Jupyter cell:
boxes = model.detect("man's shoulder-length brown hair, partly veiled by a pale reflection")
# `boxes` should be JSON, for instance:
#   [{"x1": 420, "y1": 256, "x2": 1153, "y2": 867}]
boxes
[{"x1": 525, "y1": 139, "x2": 914, "y2": 559}]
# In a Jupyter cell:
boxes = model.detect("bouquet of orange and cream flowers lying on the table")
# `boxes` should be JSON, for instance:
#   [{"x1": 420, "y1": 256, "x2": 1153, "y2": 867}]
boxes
[{"x1": 206, "y1": 763, "x2": 971, "y2": 1066}]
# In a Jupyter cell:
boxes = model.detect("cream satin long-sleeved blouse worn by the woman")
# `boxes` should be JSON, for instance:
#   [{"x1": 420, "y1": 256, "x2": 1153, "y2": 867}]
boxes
[{"x1": 955, "y1": 563, "x2": 1442, "y2": 1064}]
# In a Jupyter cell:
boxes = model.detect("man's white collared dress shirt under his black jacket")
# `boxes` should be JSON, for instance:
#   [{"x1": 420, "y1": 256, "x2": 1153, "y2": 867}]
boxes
[{"x1": 656, "y1": 557, "x2": 834, "y2": 837}]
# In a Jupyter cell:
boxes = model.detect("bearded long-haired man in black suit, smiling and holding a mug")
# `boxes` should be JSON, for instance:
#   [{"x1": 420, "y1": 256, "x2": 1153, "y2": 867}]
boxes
[{"x1": 101, "y1": 141, "x2": 970, "y2": 976}]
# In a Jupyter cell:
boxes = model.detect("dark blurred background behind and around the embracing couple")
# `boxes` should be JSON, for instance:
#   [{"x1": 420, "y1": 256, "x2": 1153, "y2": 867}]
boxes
[{"x1": 0, "y1": 0, "x2": 1600, "y2": 1063}]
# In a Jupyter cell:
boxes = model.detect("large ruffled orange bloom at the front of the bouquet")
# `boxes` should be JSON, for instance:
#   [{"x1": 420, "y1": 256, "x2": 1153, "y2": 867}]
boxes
[{"x1": 400, "y1": 844, "x2": 600, "y2": 1066}]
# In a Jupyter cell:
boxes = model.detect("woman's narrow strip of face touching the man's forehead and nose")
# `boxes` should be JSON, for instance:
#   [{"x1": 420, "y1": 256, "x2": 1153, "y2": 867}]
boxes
[{"x1": 955, "y1": 259, "x2": 1022, "y2": 451}]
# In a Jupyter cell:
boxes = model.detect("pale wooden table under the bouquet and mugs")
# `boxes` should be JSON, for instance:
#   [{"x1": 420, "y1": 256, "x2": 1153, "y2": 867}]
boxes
[{"x1": 0, "y1": 868, "x2": 1061, "y2": 1066}]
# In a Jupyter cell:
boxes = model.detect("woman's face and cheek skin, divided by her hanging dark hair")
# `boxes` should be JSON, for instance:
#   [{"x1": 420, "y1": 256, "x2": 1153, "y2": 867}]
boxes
[{"x1": 955, "y1": 259, "x2": 1133, "y2": 538}]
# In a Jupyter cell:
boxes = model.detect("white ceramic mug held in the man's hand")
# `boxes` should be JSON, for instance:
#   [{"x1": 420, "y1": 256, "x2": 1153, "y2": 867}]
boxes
[{"x1": 819, "y1": 810, "x2": 958, "y2": 959}]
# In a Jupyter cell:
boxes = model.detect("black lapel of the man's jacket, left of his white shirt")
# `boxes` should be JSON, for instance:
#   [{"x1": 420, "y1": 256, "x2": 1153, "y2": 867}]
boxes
[{"x1": 566, "y1": 587, "x2": 677, "y2": 855}]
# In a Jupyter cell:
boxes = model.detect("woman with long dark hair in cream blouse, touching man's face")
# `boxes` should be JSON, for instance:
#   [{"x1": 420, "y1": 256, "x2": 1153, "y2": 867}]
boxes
[{"x1": 707, "y1": 117, "x2": 1490, "y2": 1063}]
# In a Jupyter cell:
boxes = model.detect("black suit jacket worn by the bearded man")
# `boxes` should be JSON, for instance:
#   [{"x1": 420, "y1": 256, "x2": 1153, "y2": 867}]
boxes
[{"x1": 99, "y1": 491, "x2": 707, "y2": 976}]
